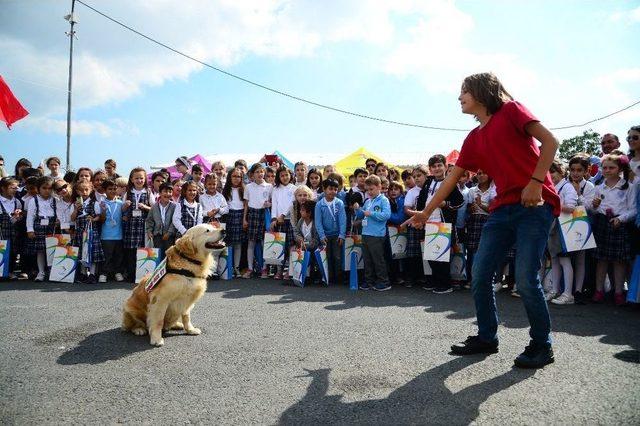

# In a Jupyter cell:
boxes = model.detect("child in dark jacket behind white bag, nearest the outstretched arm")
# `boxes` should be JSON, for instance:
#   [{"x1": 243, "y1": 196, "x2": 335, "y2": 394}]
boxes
[{"x1": 414, "y1": 154, "x2": 464, "y2": 294}]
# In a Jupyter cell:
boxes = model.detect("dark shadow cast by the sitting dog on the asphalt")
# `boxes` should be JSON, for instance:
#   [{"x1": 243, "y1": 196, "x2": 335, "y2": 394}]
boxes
[{"x1": 57, "y1": 328, "x2": 153, "y2": 365}]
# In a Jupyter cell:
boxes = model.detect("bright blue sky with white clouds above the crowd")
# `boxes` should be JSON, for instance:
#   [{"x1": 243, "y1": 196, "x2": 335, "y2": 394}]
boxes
[{"x1": 0, "y1": 0, "x2": 640, "y2": 171}]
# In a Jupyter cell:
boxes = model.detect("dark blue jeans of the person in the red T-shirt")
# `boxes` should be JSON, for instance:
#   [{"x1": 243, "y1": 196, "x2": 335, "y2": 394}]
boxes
[{"x1": 471, "y1": 204, "x2": 554, "y2": 345}]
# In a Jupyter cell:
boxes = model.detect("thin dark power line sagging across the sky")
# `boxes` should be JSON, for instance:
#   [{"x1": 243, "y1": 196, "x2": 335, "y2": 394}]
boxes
[{"x1": 76, "y1": 0, "x2": 640, "y2": 132}]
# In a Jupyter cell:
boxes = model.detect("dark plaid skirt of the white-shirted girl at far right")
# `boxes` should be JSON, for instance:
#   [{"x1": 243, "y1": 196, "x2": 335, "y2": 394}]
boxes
[{"x1": 593, "y1": 213, "x2": 633, "y2": 261}]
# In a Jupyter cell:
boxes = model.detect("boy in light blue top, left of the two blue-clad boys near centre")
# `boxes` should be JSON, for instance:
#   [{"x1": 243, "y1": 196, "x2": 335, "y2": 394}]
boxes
[{"x1": 314, "y1": 179, "x2": 347, "y2": 284}]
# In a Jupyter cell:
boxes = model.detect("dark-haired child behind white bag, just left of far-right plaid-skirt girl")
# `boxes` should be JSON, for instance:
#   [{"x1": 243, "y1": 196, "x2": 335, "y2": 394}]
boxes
[{"x1": 569, "y1": 154, "x2": 595, "y2": 303}]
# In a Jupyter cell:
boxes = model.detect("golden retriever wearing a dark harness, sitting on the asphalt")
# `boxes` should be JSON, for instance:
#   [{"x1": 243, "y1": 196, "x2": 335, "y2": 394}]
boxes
[{"x1": 122, "y1": 224, "x2": 224, "y2": 346}]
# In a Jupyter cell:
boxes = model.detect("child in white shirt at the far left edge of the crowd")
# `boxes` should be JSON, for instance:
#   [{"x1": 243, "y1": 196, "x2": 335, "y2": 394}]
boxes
[{"x1": 0, "y1": 177, "x2": 28, "y2": 280}]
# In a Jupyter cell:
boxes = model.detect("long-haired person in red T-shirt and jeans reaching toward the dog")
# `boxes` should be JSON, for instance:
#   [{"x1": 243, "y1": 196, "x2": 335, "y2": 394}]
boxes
[{"x1": 405, "y1": 73, "x2": 560, "y2": 368}]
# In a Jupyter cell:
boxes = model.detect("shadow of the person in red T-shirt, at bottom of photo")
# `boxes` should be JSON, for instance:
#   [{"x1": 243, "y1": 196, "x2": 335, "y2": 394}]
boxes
[{"x1": 278, "y1": 356, "x2": 534, "y2": 424}]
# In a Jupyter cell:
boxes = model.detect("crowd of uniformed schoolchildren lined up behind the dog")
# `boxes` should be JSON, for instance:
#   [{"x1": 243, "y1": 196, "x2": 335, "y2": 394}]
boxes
[{"x1": 0, "y1": 126, "x2": 640, "y2": 305}]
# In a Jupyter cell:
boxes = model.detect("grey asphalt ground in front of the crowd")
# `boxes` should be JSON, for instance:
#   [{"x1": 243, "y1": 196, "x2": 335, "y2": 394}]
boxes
[{"x1": 0, "y1": 280, "x2": 640, "y2": 425}]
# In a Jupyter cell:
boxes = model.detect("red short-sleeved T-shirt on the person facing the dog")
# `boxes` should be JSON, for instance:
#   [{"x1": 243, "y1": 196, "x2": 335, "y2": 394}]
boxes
[{"x1": 456, "y1": 101, "x2": 560, "y2": 216}]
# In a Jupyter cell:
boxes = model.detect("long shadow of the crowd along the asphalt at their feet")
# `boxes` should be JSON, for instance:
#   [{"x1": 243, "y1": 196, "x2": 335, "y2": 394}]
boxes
[{"x1": 207, "y1": 280, "x2": 640, "y2": 362}]
